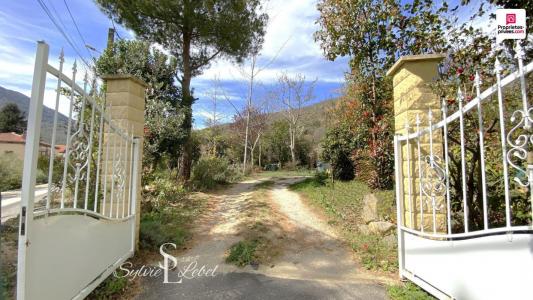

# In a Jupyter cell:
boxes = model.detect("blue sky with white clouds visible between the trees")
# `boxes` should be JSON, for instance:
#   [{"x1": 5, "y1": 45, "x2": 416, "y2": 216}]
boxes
[{"x1": 0, "y1": 0, "x2": 494, "y2": 128}]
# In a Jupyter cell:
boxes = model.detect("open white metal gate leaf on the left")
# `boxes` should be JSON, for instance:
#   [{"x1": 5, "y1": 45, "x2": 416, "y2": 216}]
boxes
[{"x1": 17, "y1": 42, "x2": 140, "y2": 299}]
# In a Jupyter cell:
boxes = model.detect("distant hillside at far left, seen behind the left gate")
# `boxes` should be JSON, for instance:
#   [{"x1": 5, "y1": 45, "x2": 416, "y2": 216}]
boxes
[{"x1": 0, "y1": 86, "x2": 68, "y2": 144}]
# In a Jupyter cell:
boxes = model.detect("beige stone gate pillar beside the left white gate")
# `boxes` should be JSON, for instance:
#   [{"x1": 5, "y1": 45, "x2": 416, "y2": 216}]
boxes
[{"x1": 102, "y1": 75, "x2": 148, "y2": 248}]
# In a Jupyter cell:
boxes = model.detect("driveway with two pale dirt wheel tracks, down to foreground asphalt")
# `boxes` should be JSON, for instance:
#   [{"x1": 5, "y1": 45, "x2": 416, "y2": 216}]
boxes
[{"x1": 138, "y1": 177, "x2": 387, "y2": 300}]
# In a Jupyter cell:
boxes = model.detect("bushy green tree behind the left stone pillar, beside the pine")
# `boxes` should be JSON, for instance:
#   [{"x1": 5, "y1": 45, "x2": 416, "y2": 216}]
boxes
[{"x1": 96, "y1": 40, "x2": 186, "y2": 168}]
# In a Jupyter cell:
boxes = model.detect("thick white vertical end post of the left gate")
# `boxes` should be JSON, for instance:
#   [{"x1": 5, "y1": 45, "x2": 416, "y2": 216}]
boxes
[{"x1": 17, "y1": 41, "x2": 49, "y2": 300}]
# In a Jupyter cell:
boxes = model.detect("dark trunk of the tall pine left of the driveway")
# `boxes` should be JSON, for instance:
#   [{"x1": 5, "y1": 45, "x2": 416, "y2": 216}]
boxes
[{"x1": 179, "y1": 32, "x2": 194, "y2": 183}]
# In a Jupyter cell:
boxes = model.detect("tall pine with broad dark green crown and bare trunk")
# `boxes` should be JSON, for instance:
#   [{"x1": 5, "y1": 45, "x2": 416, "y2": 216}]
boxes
[{"x1": 97, "y1": 0, "x2": 268, "y2": 180}]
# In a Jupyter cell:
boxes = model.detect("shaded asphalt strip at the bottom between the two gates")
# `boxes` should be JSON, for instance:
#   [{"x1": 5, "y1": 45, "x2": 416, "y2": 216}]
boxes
[{"x1": 137, "y1": 272, "x2": 388, "y2": 300}]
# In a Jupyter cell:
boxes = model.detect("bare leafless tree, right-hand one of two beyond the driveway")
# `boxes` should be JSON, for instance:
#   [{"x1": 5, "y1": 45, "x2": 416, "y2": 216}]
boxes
[{"x1": 273, "y1": 73, "x2": 316, "y2": 166}]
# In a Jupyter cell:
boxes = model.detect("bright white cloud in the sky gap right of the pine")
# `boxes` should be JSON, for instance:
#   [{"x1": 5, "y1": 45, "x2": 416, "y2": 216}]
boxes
[{"x1": 194, "y1": 0, "x2": 336, "y2": 83}]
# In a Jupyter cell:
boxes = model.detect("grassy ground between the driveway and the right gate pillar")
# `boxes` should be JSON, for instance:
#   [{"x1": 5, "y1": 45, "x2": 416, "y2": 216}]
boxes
[{"x1": 289, "y1": 176, "x2": 398, "y2": 272}]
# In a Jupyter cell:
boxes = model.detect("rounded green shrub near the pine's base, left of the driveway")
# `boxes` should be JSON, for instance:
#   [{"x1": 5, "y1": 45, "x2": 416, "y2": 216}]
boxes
[{"x1": 191, "y1": 157, "x2": 239, "y2": 190}]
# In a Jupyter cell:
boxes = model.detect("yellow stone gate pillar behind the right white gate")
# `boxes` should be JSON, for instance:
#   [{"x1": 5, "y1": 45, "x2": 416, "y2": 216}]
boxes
[{"x1": 387, "y1": 54, "x2": 446, "y2": 232}]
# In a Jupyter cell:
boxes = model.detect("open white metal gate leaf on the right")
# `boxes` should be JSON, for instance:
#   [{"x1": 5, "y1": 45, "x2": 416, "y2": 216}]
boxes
[{"x1": 394, "y1": 43, "x2": 533, "y2": 300}]
